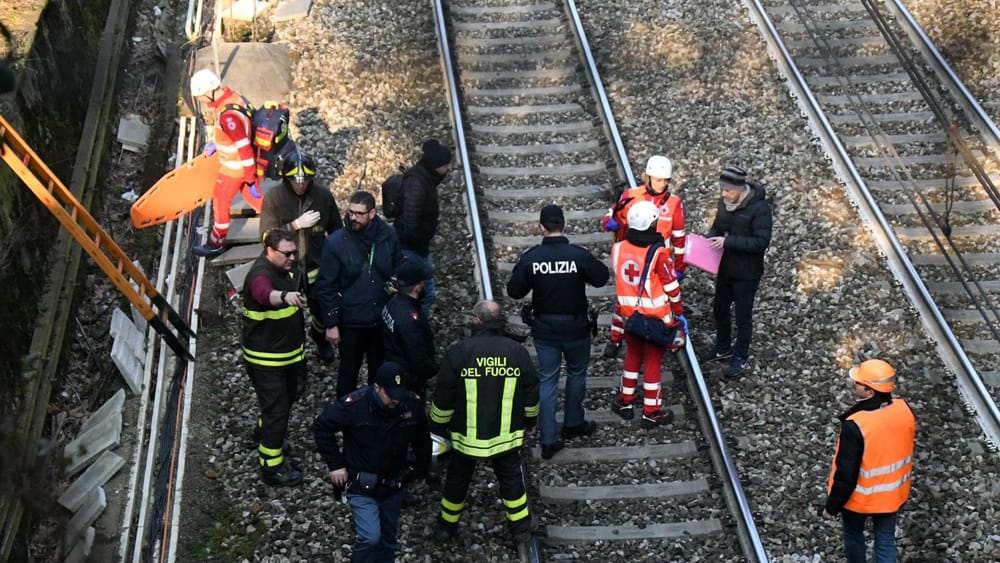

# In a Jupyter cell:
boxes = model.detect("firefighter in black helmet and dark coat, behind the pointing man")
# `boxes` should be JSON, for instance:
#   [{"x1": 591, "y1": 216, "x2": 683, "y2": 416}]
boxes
[{"x1": 260, "y1": 148, "x2": 344, "y2": 364}]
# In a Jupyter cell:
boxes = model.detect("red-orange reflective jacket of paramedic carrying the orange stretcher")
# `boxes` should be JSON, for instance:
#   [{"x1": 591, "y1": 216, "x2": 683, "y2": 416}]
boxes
[{"x1": 210, "y1": 87, "x2": 256, "y2": 181}]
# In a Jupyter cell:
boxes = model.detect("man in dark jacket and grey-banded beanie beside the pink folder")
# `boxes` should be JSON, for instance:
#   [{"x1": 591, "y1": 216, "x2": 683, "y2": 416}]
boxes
[{"x1": 702, "y1": 166, "x2": 773, "y2": 376}]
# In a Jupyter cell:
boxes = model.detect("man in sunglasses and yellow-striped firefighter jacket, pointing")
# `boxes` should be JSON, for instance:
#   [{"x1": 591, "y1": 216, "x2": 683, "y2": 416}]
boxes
[{"x1": 242, "y1": 229, "x2": 307, "y2": 487}]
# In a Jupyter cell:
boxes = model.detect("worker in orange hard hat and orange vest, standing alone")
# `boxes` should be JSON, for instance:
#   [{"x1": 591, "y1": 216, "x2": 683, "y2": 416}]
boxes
[{"x1": 823, "y1": 360, "x2": 916, "y2": 563}]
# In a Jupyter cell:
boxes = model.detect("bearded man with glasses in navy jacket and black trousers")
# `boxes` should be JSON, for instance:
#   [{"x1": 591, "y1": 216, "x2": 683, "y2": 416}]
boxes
[{"x1": 316, "y1": 192, "x2": 401, "y2": 397}]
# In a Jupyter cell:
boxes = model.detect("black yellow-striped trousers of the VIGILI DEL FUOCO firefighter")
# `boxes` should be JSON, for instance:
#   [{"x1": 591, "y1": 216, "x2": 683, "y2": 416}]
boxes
[{"x1": 440, "y1": 448, "x2": 531, "y2": 539}]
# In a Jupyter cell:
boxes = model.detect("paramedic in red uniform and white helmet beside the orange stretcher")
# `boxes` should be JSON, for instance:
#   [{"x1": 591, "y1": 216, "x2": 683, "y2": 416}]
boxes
[{"x1": 191, "y1": 69, "x2": 263, "y2": 257}]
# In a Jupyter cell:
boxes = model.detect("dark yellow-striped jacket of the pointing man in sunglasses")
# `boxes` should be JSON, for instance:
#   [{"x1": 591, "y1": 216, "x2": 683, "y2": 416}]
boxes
[{"x1": 243, "y1": 250, "x2": 306, "y2": 367}]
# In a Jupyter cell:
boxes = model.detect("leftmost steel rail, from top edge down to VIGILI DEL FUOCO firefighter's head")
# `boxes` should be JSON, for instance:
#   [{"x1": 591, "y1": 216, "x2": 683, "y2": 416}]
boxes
[{"x1": 433, "y1": 0, "x2": 493, "y2": 299}]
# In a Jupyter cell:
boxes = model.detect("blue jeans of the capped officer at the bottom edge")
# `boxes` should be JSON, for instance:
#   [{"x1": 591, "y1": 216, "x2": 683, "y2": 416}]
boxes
[{"x1": 347, "y1": 489, "x2": 404, "y2": 563}]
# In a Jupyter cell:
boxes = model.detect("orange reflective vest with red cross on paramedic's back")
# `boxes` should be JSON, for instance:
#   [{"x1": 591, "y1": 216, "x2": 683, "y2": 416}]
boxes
[{"x1": 611, "y1": 240, "x2": 681, "y2": 325}]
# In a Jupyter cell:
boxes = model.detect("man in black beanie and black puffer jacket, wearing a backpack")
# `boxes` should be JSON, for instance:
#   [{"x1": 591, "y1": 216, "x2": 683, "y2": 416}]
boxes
[{"x1": 393, "y1": 139, "x2": 451, "y2": 319}]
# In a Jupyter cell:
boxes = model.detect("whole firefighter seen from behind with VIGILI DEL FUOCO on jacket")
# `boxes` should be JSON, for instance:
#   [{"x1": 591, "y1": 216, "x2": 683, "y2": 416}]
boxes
[{"x1": 431, "y1": 300, "x2": 538, "y2": 561}]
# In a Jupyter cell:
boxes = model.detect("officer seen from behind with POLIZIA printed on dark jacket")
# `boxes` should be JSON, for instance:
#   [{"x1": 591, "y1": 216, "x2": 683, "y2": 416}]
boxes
[{"x1": 507, "y1": 205, "x2": 611, "y2": 459}]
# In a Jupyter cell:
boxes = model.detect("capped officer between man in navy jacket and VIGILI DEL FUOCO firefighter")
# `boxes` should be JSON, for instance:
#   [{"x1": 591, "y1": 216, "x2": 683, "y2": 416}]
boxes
[{"x1": 382, "y1": 258, "x2": 438, "y2": 480}]
